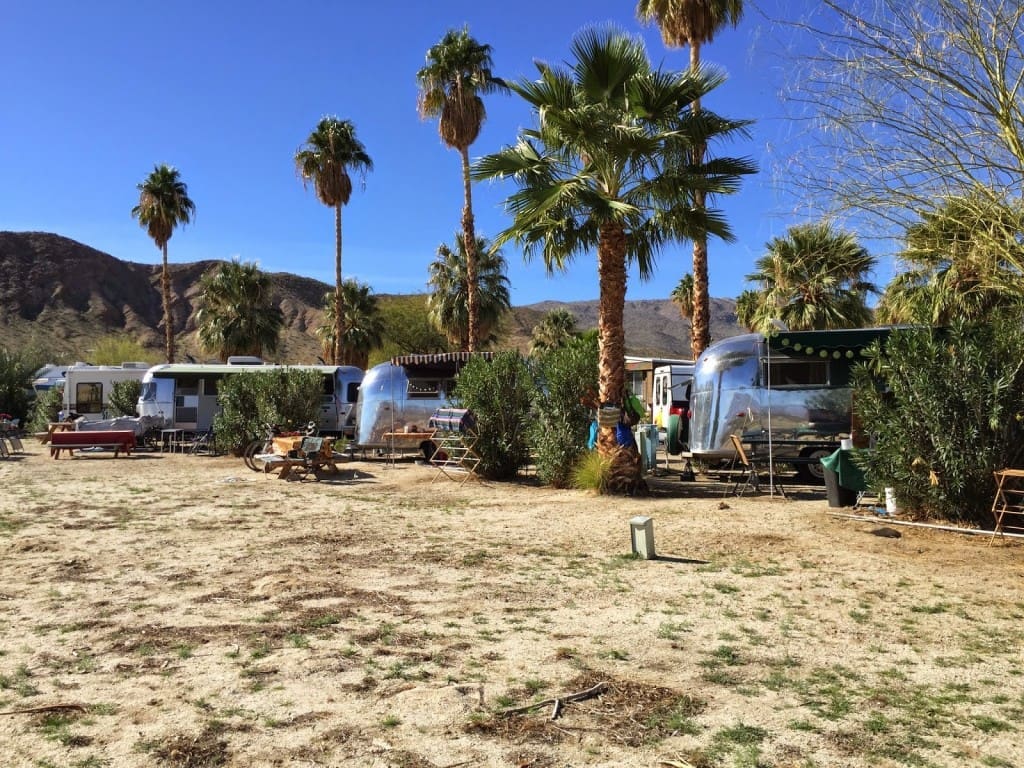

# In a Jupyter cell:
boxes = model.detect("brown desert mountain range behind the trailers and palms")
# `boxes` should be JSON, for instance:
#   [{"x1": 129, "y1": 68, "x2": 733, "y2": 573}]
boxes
[{"x1": 0, "y1": 231, "x2": 740, "y2": 362}]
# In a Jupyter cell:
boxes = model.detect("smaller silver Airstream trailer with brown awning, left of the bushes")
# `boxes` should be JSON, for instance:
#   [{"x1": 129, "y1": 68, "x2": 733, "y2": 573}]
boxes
[{"x1": 354, "y1": 352, "x2": 493, "y2": 456}]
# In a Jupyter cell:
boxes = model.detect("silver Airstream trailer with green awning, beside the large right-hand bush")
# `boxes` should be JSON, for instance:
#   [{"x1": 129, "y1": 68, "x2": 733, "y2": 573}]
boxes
[{"x1": 689, "y1": 328, "x2": 891, "y2": 479}]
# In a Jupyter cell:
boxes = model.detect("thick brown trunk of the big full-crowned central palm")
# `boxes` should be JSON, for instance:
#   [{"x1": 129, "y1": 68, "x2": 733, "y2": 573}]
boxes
[{"x1": 597, "y1": 223, "x2": 640, "y2": 492}]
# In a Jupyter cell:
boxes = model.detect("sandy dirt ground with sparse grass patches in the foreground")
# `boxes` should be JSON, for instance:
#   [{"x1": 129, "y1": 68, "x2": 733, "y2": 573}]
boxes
[{"x1": 0, "y1": 441, "x2": 1024, "y2": 768}]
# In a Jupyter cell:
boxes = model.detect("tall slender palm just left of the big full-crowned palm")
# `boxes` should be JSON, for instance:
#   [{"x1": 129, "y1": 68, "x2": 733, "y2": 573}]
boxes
[{"x1": 416, "y1": 28, "x2": 508, "y2": 352}]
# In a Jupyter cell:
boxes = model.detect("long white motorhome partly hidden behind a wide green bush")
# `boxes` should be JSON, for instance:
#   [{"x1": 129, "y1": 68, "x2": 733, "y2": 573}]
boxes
[{"x1": 138, "y1": 358, "x2": 362, "y2": 435}]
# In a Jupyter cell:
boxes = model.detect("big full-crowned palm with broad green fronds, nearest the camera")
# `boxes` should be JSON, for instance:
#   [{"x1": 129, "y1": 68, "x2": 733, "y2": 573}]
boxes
[{"x1": 474, "y1": 29, "x2": 754, "y2": 493}]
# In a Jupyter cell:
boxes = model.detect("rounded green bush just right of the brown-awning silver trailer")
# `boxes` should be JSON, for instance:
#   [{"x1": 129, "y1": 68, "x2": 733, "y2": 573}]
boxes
[{"x1": 454, "y1": 352, "x2": 534, "y2": 480}]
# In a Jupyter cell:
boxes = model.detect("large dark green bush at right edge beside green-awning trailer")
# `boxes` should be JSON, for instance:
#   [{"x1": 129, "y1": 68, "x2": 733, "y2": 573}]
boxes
[{"x1": 854, "y1": 316, "x2": 1024, "y2": 526}]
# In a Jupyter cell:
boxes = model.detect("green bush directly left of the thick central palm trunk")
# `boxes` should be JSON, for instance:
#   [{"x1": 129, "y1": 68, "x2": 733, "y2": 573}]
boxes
[{"x1": 529, "y1": 337, "x2": 597, "y2": 487}]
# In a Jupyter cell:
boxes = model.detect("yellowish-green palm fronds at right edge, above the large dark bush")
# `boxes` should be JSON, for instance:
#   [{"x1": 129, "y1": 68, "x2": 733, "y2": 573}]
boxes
[{"x1": 877, "y1": 194, "x2": 1024, "y2": 326}]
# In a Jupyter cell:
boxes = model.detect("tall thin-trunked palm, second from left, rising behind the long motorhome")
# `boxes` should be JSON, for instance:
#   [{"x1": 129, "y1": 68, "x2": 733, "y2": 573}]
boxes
[{"x1": 295, "y1": 117, "x2": 374, "y2": 366}]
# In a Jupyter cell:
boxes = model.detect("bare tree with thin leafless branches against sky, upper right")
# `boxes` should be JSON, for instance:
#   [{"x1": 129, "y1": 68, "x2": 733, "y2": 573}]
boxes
[{"x1": 782, "y1": 0, "x2": 1024, "y2": 236}]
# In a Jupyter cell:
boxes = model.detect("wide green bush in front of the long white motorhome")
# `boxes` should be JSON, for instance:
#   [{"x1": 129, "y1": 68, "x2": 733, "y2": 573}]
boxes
[{"x1": 213, "y1": 368, "x2": 324, "y2": 452}]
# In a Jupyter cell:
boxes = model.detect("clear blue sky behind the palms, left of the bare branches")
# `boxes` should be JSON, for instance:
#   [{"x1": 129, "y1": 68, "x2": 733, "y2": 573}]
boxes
[{"x1": 0, "y1": 0, "x2": 860, "y2": 306}]
